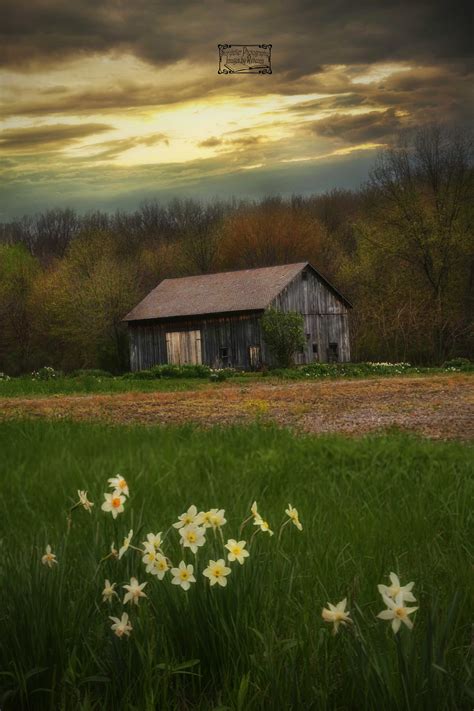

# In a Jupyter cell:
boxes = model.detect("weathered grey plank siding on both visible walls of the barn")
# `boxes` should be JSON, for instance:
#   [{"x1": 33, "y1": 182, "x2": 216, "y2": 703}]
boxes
[{"x1": 129, "y1": 268, "x2": 351, "y2": 370}]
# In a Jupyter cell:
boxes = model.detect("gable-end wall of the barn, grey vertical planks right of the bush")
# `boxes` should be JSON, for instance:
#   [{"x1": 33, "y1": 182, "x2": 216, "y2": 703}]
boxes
[{"x1": 271, "y1": 269, "x2": 351, "y2": 364}]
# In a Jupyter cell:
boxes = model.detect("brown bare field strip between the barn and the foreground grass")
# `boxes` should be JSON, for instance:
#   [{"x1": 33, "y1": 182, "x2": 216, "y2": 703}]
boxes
[{"x1": 0, "y1": 374, "x2": 474, "y2": 440}]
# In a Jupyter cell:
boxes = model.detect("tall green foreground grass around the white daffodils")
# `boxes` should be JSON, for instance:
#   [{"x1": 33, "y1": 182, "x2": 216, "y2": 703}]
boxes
[{"x1": 0, "y1": 421, "x2": 474, "y2": 711}]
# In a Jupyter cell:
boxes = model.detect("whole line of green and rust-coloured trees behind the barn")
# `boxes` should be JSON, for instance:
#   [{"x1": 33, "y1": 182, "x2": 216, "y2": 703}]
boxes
[{"x1": 0, "y1": 126, "x2": 474, "y2": 374}]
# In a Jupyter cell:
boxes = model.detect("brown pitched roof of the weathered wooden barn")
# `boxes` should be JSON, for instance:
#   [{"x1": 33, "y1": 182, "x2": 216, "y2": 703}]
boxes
[{"x1": 123, "y1": 262, "x2": 350, "y2": 321}]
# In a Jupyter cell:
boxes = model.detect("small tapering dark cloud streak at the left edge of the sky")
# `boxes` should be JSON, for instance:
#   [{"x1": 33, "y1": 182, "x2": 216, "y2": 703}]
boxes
[{"x1": 0, "y1": 123, "x2": 113, "y2": 151}]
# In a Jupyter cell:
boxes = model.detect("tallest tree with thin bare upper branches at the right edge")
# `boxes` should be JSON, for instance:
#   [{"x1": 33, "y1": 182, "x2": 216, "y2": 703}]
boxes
[{"x1": 360, "y1": 126, "x2": 474, "y2": 362}]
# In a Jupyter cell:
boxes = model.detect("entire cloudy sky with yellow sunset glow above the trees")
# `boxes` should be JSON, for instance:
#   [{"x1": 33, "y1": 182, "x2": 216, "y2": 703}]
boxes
[{"x1": 0, "y1": 0, "x2": 474, "y2": 221}]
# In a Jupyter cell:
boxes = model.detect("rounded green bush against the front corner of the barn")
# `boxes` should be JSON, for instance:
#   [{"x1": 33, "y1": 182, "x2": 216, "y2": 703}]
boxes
[{"x1": 261, "y1": 309, "x2": 306, "y2": 368}]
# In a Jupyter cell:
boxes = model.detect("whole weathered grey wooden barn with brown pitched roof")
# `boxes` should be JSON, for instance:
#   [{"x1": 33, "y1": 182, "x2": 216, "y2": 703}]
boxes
[{"x1": 124, "y1": 262, "x2": 351, "y2": 370}]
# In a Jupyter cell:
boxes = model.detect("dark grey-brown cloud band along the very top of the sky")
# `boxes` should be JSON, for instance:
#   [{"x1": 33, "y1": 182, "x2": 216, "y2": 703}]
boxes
[{"x1": 0, "y1": 0, "x2": 472, "y2": 72}]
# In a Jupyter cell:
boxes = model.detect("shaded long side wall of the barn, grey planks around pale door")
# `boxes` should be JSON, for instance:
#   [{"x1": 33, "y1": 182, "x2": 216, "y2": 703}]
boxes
[{"x1": 129, "y1": 314, "x2": 262, "y2": 371}]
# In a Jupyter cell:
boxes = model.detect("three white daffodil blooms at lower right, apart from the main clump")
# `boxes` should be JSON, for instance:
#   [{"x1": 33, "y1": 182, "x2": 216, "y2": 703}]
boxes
[{"x1": 321, "y1": 573, "x2": 418, "y2": 634}]
